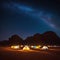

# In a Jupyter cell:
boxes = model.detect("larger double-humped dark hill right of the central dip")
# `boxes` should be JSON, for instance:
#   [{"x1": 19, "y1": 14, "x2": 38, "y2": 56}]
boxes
[{"x1": 25, "y1": 31, "x2": 60, "y2": 45}]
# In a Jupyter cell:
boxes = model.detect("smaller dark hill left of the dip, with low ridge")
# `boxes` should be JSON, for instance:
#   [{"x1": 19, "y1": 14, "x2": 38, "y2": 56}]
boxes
[{"x1": 0, "y1": 34, "x2": 23, "y2": 46}]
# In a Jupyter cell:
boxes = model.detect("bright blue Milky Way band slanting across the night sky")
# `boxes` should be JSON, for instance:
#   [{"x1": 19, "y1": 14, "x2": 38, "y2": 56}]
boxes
[{"x1": 4, "y1": 3, "x2": 60, "y2": 28}]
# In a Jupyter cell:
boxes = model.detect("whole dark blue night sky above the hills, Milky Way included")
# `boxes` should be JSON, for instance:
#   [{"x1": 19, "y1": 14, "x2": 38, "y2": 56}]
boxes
[{"x1": 0, "y1": 0, "x2": 60, "y2": 40}]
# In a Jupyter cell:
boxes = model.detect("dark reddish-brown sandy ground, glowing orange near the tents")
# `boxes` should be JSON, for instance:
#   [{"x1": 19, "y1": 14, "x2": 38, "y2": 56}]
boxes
[{"x1": 0, "y1": 47, "x2": 60, "y2": 60}]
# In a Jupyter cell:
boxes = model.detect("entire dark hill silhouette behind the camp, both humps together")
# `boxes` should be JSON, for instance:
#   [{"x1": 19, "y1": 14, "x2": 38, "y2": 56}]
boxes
[{"x1": 0, "y1": 31, "x2": 60, "y2": 45}]
